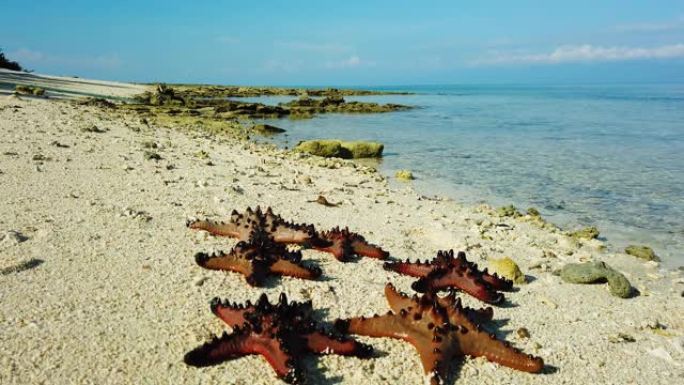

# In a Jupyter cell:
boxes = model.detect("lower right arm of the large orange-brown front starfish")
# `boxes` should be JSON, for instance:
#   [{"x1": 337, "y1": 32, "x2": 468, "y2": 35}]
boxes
[{"x1": 458, "y1": 328, "x2": 544, "y2": 373}]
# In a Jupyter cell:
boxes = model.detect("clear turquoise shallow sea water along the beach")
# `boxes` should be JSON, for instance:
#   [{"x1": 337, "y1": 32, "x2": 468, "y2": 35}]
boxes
[{"x1": 252, "y1": 84, "x2": 684, "y2": 266}]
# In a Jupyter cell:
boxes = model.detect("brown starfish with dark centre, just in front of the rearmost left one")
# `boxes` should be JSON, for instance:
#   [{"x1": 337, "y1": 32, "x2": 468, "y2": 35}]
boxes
[{"x1": 195, "y1": 229, "x2": 321, "y2": 286}]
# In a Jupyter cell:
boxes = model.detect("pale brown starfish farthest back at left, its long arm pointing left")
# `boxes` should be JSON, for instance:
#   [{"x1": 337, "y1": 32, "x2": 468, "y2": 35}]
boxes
[{"x1": 186, "y1": 206, "x2": 327, "y2": 246}]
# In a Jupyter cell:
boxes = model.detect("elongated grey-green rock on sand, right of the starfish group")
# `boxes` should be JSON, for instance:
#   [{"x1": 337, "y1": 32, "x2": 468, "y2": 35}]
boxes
[{"x1": 560, "y1": 261, "x2": 632, "y2": 298}]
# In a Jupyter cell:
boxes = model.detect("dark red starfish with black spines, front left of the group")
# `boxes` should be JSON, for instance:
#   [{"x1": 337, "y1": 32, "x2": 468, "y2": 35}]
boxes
[{"x1": 184, "y1": 293, "x2": 373, "y2": 384}]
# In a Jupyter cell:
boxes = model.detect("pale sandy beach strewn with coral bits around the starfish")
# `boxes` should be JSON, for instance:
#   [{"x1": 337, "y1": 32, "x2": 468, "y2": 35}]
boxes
[{"x1": 0, "y1": 98, "x2": 684, "y2": 385}]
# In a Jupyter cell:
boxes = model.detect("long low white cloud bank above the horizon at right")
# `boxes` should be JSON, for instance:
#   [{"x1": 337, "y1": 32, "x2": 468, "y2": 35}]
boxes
[{"x1": 471, "y1": 44, "x2": 684, "y2": 65}]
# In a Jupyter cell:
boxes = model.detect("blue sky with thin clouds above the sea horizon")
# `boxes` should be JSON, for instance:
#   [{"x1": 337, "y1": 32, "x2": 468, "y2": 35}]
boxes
[{"x1": 0, "y1": 0, "x2": 684, "y2": 85}]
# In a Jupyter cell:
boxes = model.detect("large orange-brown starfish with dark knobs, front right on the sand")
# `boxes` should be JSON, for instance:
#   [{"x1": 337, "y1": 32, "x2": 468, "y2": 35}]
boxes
[{"x1": 335, "y1": 283, "x2": 544, "y2": 385}]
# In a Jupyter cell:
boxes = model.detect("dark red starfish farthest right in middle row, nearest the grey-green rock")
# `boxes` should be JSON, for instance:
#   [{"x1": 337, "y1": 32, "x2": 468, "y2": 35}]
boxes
[{"x1": 384, "y1": 250, "x2": 513, "y2": 304}]
